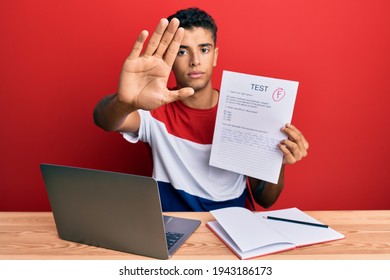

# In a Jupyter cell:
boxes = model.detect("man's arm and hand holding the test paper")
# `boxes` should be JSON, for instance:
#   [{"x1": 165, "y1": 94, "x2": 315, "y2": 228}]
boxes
[{"x1": 248, "y1": 124, "x2": 309, "y2": 208}]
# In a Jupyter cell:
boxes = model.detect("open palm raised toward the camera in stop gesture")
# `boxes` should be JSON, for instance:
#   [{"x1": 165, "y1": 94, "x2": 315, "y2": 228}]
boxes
[{"x1": 118, "y1": 18, "x2": 194, "y2": 110}]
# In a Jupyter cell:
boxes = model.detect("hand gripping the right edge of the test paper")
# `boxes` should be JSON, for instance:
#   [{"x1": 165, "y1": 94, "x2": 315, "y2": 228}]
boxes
[{"x1": 279, "y1": 124, "x2": 309, "y2": 164}]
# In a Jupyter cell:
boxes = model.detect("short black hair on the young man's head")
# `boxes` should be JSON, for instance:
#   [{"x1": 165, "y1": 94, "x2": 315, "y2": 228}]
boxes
[{"x1": 168, "y1": 8, "x2": 217, "y2": 44}]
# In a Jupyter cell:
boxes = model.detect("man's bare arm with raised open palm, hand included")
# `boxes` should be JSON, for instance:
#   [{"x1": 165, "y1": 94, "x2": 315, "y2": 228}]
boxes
[{"x1": 94, "y1": 19, "x2": 194, "y2": 132}]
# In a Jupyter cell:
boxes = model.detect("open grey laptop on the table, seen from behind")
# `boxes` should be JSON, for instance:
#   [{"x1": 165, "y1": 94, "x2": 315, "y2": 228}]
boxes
[{"x1": 40, "y1": 164, "x2": 200, "y2": 259}]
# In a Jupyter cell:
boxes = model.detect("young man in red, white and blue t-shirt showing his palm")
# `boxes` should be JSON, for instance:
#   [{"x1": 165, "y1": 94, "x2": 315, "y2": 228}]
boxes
[{"x1": 94, "y1": 8, "x2": 308, "y2": 211}]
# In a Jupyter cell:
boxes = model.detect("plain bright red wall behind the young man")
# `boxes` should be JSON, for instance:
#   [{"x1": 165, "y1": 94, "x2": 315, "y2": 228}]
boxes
[{"x1": 0, "y1": 0, "x2": 390, "y2": 211}]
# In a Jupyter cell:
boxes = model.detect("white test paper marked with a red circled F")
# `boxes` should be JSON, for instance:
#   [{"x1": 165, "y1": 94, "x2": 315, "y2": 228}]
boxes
[{"x1": 210, "y1": 71, "x2": 298, "y2": 183}]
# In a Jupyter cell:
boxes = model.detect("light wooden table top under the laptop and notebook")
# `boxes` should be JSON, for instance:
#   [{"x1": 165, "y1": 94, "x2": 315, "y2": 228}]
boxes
[{"x1": 0, "y1": 210, "x2": 390, "y2": 260}]
